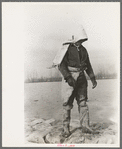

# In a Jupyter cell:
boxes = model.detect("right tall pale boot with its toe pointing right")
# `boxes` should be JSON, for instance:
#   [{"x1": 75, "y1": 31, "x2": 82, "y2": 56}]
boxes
[{"x1": 79, "y1": 105, "x2": 99, "y2": 134}]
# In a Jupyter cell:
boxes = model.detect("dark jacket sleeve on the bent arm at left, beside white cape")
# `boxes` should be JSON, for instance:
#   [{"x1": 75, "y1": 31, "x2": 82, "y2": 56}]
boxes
[{"x1": 58, "y1": 53, "x2": 71, "y2": 80}]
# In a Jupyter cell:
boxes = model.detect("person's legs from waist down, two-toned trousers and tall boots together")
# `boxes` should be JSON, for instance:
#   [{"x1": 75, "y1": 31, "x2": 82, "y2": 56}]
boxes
[{"x1": 62, "y1": 68, "x2": 99, "y2": 137}]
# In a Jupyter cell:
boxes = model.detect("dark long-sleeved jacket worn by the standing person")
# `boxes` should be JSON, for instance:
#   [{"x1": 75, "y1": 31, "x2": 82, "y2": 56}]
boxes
[{"x1": 59, "y1": 45, "x2": 95, "y2": 81}]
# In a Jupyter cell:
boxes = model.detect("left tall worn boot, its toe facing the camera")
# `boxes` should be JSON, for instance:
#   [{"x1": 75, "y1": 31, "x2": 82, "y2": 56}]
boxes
[{"x1": 62, "y1": 109, "x2": 71, "y2": 138}]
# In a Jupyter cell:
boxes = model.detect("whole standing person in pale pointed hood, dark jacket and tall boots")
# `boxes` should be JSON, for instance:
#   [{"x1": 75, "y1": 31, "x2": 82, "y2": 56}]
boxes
[{"x1": 54, "y1": 27, "x2": 98, "y2": 137}]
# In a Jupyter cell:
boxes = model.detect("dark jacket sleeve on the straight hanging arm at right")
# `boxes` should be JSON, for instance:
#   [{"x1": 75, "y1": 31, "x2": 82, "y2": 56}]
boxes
[{"x1": 86, "y1": 53, "x2": 96, "y2": 82}]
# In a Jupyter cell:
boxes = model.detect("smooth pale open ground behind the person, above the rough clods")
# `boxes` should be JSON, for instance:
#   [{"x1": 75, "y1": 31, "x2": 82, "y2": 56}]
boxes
[{"x1": 24, "y1": 79, "x2": 119, "y2": 145}]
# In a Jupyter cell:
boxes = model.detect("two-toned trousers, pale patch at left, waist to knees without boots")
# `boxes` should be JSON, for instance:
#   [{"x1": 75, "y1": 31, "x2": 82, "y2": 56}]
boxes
[{"x1": 61, "y1": 67, "x2": 88, "y2": 110}]
